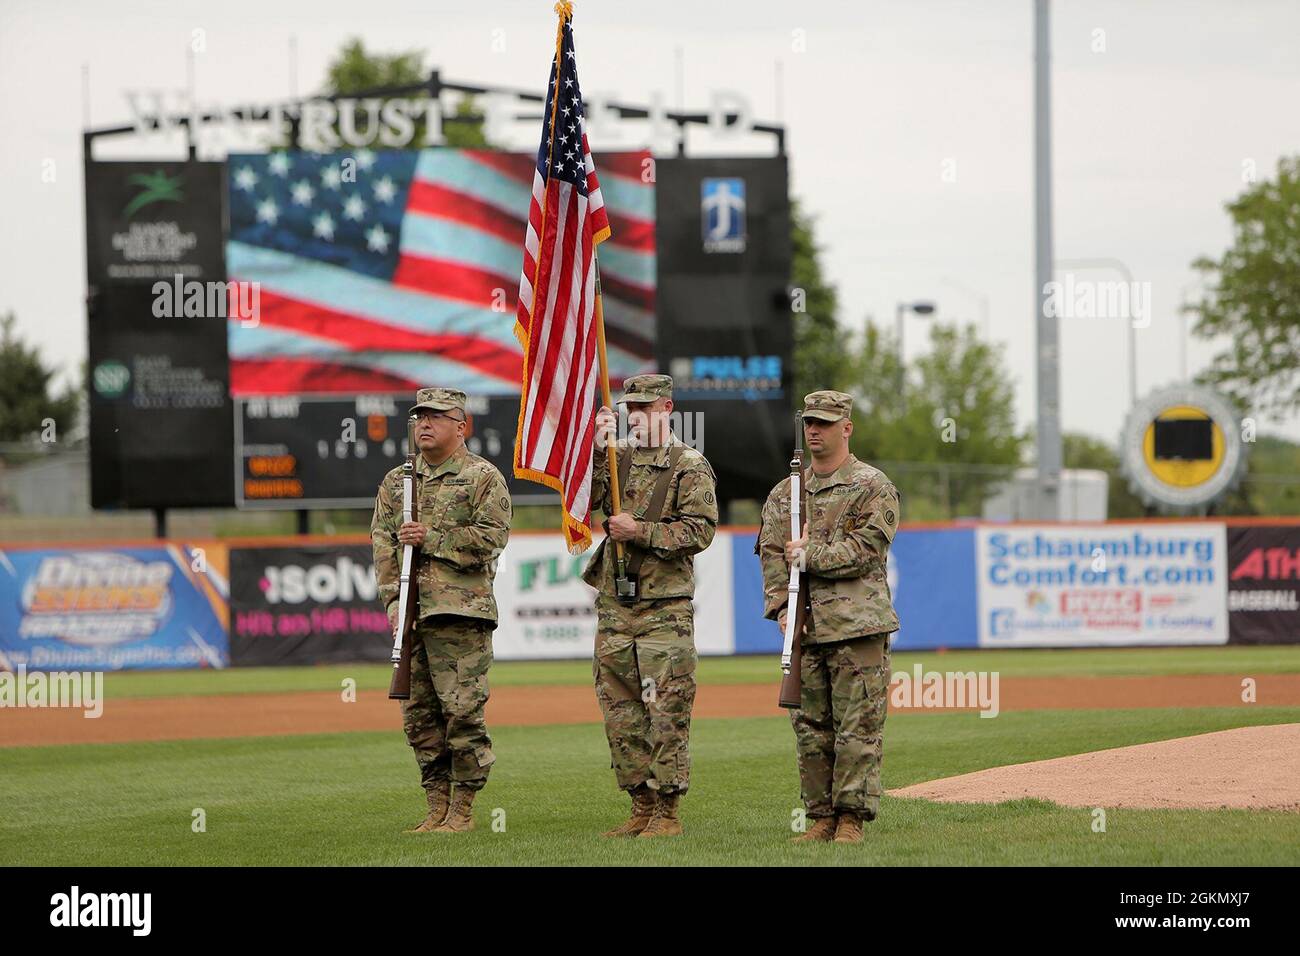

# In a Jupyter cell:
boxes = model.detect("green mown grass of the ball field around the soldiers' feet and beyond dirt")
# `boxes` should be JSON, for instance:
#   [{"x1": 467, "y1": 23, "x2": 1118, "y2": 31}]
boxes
[{"x1": 0, "y1": 648, "x2": 1300, "y2": 865}]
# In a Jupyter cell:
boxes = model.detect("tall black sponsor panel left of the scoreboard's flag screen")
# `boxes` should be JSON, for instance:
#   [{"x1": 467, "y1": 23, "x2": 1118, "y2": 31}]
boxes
[{"x1": 86, "y1": 163, "x2": 235, "y2": 509}]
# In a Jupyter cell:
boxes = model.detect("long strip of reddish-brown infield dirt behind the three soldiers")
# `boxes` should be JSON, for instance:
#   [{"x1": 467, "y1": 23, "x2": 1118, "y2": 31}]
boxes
[{"x1": 0, "y1": 674, "x2": 1300, "y2": 747}]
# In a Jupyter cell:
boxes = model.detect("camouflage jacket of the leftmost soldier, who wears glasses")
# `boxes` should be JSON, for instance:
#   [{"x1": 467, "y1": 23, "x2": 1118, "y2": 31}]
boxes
[{"x1": 371, "y1": 446, "x2": 511, "y2": 622}]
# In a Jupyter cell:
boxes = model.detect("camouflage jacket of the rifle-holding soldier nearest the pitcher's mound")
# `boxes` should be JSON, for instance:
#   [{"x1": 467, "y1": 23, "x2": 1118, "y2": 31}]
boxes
[{"x1": 758, "y1": 455, "x2": 900, "y2": 644}]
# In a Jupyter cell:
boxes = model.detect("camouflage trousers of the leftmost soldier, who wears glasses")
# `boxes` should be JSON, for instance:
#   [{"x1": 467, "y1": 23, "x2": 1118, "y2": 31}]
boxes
[{"x1": 402, "y1": 614, "x2": 497, "y2": 790}]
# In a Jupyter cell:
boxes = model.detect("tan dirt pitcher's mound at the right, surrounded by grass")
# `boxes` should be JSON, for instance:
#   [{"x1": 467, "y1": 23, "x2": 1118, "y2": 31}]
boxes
[{"x1": 889, "y1": 723, "x2": 1300, "y2": 810}]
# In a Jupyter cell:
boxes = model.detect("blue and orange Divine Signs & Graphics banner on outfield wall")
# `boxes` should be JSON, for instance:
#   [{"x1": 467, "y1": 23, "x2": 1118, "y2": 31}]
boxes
[{"x1": 0, "y1": 544, "x2": 230, "y2": 671}]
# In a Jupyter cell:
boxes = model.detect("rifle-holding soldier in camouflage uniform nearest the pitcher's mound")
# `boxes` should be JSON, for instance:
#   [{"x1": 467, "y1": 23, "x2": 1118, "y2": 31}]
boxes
[{"x1": 758, "y1": 392, "x2": 900, "y2": 843}]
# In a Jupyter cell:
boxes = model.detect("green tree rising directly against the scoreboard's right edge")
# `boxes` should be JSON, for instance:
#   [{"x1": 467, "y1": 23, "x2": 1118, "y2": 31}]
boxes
[{"x1": 790, "y1": 200, "x2": 853, "y2": 402}]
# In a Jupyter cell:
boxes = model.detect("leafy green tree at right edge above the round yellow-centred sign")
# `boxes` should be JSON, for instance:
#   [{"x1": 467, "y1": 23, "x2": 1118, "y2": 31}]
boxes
[{"x1": 1186, "y1": 156, "x2": 1300, "y2": 412}]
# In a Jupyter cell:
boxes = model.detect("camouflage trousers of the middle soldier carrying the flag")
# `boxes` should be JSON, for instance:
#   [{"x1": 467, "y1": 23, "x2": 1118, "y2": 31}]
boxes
[{"x1": 592, "y1": 594, "x2": 696, "y2": 793}]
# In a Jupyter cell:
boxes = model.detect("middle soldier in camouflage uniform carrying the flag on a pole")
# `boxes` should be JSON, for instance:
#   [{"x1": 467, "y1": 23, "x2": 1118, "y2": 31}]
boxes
[{"x1": 582, "y1": 375, "x2": 718, "y2": 836}]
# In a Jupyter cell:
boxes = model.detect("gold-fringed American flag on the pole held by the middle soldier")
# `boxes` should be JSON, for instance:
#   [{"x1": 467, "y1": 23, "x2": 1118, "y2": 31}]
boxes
[{"x1": 515, "y1": 1, "x2": 611, "y2": 554}]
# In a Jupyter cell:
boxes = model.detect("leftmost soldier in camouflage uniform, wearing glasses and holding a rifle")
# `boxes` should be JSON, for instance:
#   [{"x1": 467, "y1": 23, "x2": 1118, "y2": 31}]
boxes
[{"x1": 371, "y1": 388, "x2": 511, "y2": 832}]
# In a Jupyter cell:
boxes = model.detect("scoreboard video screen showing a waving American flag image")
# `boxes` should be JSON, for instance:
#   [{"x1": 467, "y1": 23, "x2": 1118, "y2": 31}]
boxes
[{"x1": 226, "y1": 148, "x2": 657, "y2": 397}]
